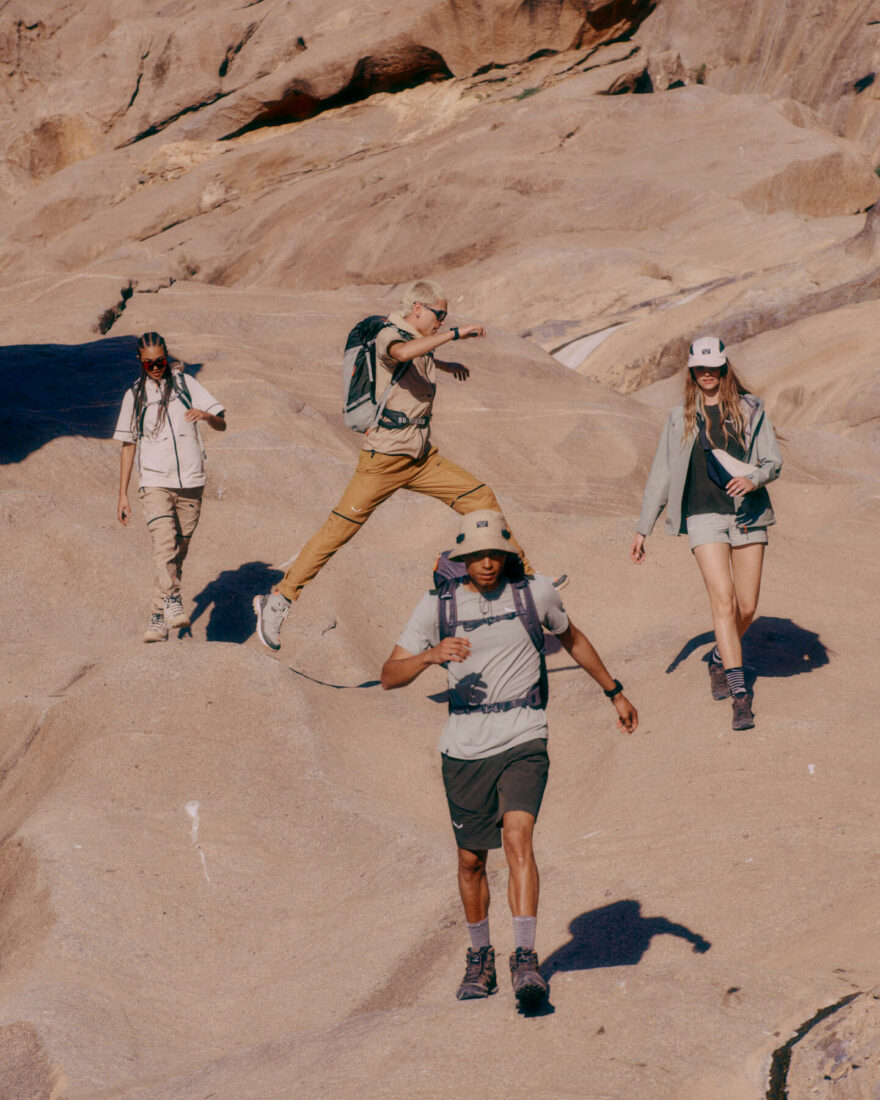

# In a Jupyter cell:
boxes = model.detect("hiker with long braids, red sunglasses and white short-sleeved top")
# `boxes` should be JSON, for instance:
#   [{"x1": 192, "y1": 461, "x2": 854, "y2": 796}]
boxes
[{"x1": 113, "y1": 332, "x2": 227, "y2": 641}]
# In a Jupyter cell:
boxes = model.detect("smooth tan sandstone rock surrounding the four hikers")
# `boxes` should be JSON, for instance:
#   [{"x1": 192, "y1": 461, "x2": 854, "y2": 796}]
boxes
[{"x1": 0, "y1": 0, "x2": 880, "y2": 1100}]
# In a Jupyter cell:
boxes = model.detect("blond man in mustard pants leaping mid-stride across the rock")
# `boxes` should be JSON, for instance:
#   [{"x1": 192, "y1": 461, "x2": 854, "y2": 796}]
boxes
[{"x1": 254, "y1": 279, "x2": 556, "y2": 649}]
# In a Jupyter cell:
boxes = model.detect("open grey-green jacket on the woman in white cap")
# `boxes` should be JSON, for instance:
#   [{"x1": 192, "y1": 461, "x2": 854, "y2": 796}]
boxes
[{"x1": 636, "y1": 394, "x2": 782, "y2": 538}]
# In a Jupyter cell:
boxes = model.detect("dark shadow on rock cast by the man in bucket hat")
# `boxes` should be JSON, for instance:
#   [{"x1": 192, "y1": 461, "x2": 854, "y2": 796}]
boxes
[{"x1": 541, "y1": 900, "x2": 712, "y2": 978}]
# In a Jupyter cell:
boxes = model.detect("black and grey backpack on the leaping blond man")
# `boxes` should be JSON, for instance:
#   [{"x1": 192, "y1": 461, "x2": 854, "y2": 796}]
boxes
[{"x1": 342, "y1": 315, "x2": 430, "y2": 433}]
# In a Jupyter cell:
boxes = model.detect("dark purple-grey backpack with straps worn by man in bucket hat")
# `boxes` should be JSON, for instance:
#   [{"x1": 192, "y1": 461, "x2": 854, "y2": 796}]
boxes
[{"x1": 432, "y1": 551, "x2": 549, "y2": 714}]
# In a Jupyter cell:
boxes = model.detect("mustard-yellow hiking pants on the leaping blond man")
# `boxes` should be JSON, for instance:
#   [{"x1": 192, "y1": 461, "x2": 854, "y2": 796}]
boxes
[{"x1": 278, "y1": 447, "x2": 532, "y2": 600}]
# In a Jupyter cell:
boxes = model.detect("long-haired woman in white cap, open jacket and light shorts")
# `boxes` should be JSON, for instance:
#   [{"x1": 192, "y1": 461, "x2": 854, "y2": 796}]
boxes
[{"x1": 629, "y1": 337, "x2": 782, "y2": 729}]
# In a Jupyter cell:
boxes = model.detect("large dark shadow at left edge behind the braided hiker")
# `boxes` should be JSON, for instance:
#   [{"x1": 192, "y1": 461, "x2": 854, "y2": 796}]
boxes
[{"x1": 0, "y1": 337, "x2": 201, "y2": 465}]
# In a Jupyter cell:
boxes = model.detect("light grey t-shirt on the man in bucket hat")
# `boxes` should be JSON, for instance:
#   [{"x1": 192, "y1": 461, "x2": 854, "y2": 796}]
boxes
[{"x1": 397, "y1": 576, "x2": 569, "y2": 760}]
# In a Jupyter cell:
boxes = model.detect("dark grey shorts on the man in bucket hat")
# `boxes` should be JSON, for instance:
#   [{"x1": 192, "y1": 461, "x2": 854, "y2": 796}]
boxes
[{"x1": 442, "y1": 737, "x2": 550, "y2": 851}]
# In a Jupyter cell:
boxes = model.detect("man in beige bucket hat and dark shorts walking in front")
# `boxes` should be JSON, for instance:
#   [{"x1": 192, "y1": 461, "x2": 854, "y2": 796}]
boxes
[{"x1": 382, "y1": 510, "x2": 638, "y2": 1004}]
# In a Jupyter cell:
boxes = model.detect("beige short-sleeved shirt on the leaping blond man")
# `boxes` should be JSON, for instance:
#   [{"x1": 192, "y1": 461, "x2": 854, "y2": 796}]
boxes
[{"x1": 362, "y1": 314, "x2": 437, "y2": 459}]
